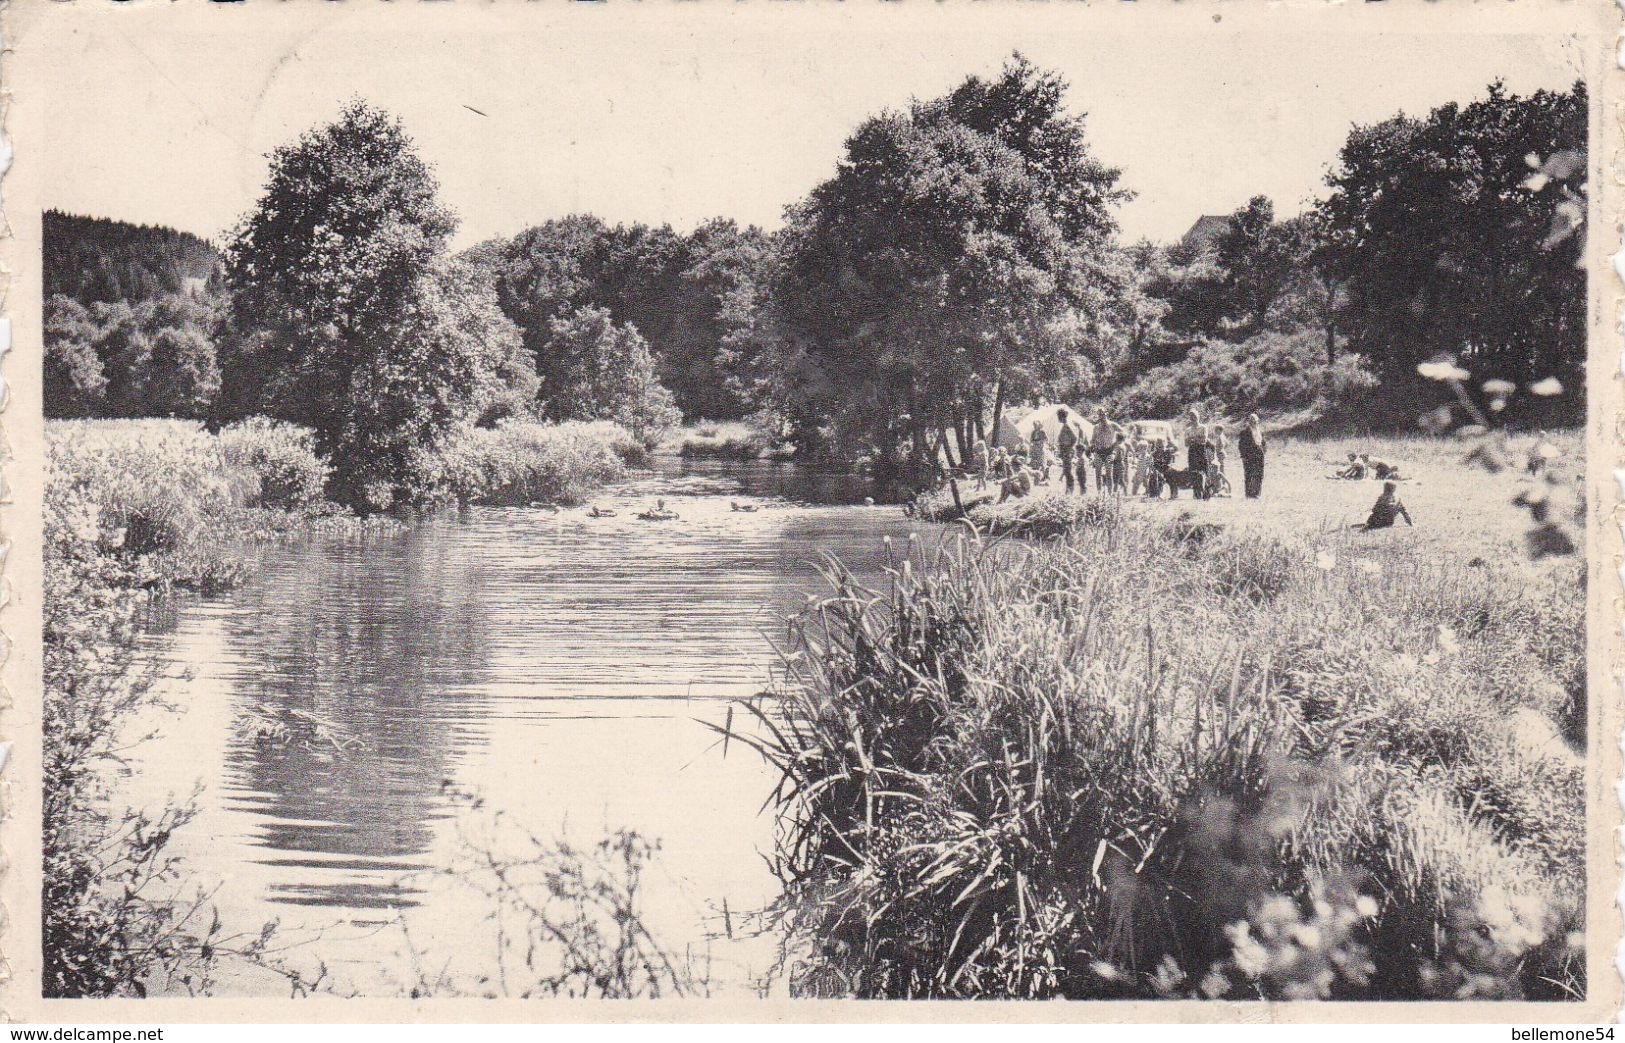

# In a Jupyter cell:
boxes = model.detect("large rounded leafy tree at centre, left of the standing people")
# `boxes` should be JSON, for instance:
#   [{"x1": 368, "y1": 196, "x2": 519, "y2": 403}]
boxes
[{"x1": 774, "y1": 55, "x2": 1123, "y2": 466}]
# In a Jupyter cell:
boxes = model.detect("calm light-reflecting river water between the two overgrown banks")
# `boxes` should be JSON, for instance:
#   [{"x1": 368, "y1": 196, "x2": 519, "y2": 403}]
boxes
[{"x1": 125, "y1": 460, "x2": 942, "y2": 993}]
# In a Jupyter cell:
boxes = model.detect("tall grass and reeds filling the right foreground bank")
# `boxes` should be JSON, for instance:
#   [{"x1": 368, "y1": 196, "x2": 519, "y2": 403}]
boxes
[{"x1": 757, "y1": 517, "x2": 1584, "y2": 999}]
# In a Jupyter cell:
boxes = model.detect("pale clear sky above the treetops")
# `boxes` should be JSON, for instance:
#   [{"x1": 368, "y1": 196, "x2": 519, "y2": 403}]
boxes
[{"x1": 34, "y1": 3, "x2": 1581, "y2": 247}]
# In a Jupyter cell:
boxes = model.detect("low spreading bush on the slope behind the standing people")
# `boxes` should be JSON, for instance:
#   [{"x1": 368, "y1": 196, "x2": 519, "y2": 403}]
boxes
[{"x1": 1103, "y1": 331, "x2": 1376, "y2": 418}]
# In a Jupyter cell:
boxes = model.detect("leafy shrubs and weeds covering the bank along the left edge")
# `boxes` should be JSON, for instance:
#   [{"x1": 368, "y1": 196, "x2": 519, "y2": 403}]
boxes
[{"x1": 41, "y1": 421, "x2": 303, "y2": 996}]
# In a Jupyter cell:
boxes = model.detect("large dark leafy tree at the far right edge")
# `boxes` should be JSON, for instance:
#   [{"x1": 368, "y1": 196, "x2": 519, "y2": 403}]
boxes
[{"x1": 1321, "y1": 83, "x2": 1588, "y2": 405}]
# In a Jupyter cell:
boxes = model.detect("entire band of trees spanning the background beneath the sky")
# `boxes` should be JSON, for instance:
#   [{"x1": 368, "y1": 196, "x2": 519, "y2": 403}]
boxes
[{"x1": 46, "y1": 65, "x2": 1588, "y2": 493}]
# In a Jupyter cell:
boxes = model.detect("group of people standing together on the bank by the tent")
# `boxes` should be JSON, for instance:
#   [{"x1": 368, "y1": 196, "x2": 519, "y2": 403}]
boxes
[{"x1": 972, "y1": 406, "x2": 1264, "y2": 502}]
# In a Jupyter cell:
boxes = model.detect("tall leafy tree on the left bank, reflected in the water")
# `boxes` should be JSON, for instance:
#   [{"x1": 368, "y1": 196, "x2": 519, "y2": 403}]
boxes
[{"x1": 226, "y1": 101, "x2": 492, "y2": 509}]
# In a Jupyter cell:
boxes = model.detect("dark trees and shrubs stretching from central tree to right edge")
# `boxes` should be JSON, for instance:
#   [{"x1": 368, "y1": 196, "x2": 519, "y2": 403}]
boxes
[{"x1": 1103, "y1": 83, "x2": 1588, "y2": 424}]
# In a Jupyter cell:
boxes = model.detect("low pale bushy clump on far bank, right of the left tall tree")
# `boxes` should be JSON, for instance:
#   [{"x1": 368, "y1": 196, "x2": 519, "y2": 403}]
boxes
[{"x1": 440, "y1": 421, "x2": 645, "y2": 505}]
